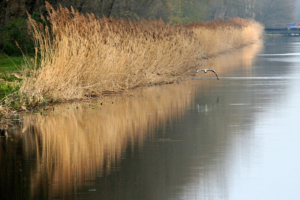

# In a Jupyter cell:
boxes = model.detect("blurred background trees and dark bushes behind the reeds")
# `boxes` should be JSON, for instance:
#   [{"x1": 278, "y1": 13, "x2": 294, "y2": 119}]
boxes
[{"x1": 0, "y1": 0, "x2": 295, "y2": 55}]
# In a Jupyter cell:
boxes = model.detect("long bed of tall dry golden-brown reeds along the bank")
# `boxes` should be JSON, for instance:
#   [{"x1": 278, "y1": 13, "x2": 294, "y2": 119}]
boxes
[{"x1": 20, "y1": 3, "x2": 262, "y2": 101}]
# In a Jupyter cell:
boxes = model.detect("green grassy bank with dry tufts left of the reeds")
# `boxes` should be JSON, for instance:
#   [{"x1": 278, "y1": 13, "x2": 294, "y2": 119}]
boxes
[{"x1": 0, "y1": 54, "x2": 48, "y2": 118}]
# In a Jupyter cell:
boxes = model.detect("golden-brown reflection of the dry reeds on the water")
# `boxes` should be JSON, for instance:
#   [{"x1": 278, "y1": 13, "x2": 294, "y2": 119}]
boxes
[{"x1": 12, "y1": 41, "x2": 259, "y2": 197}]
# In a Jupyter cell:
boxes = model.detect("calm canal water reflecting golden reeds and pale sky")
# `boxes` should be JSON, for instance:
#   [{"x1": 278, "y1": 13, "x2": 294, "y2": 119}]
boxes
[{"x1": 0, "y1": 38, "x2": 300, "y2": 200}]
